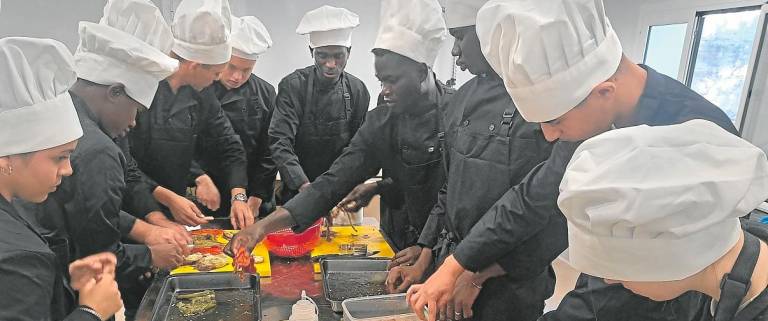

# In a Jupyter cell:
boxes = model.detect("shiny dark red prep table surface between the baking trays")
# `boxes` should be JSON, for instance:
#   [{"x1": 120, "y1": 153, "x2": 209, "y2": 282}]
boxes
[{"x1": 136, "y1": 220, "x2": 396, "y2": 321}]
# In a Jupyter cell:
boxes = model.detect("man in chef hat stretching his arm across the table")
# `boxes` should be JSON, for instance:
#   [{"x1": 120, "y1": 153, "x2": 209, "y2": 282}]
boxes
[{"x1": 228, "y1": 0, "x2": 452, "y2": 255}]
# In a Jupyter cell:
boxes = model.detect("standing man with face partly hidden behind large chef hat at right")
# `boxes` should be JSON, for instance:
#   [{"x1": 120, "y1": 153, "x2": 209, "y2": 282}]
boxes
[{"x1": 387, "y1": 0, "x2": 566, "y2": 320}]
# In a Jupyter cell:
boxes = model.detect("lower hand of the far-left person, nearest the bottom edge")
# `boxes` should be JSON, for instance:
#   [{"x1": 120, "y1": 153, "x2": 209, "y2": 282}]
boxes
[{"x1": 78, "y1": 273, "x2": 123, "y2": 321}]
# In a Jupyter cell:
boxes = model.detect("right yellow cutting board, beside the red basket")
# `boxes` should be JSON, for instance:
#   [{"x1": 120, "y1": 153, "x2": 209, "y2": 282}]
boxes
[{"x1": 311, "y1": 226, "x2": 395, "y2": 273}]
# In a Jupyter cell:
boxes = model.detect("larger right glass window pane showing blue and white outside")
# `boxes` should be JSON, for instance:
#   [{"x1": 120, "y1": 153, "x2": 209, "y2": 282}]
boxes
[{"x1": 690, "y1": 9, "x2": 760, "y2": 123}]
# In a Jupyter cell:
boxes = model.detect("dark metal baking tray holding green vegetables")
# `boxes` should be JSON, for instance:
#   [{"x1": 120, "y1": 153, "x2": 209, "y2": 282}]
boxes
[{"x1": 151, "y1": 273, "x2": 261, "y2": 321}]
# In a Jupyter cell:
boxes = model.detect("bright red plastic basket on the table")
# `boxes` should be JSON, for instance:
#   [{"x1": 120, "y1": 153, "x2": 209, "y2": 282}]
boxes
[{"x1": 264, "y1": 219, "x2": 323, "y2": 257}]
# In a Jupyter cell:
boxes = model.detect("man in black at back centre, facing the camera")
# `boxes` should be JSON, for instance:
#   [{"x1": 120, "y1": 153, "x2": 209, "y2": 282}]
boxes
[{"x1": 269, "y1": 6, "x2": 370, "y2": 204}]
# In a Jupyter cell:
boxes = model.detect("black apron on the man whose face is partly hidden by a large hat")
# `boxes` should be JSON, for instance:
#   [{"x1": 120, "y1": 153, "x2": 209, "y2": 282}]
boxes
[{"x1": 433, "y1": 104, "x2": 555, "y2": 321}]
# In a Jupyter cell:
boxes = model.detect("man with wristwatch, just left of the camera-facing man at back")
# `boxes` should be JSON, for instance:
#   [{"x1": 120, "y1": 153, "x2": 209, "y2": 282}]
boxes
[{"x1": 197, "y1": 16, "x2": 277, "y2": 227}]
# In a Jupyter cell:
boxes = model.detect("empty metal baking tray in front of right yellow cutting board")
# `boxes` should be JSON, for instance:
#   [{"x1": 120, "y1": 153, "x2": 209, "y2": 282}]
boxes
[{"x1": 320, "y1": 257, "x2": 389, "y2": 312}]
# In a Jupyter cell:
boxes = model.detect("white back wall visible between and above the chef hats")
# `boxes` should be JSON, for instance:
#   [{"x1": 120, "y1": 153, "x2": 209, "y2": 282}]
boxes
[{"x1": 0, "y1": 0, "x2": 470, "y2": 107}]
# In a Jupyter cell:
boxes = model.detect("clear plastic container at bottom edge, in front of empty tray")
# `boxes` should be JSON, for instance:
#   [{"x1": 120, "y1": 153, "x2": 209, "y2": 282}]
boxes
[{"x1": 341, "y1": 294, "x2": 419, "y2": 321}]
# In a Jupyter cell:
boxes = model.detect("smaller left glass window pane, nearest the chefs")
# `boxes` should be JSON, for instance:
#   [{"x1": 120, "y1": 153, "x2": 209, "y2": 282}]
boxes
[{"x1": 644, "y1": 23, "x2": 688, "y2": 79}]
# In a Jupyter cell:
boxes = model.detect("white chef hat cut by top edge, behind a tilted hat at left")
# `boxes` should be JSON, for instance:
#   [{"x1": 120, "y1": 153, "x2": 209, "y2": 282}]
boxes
[{"x1": 99, "y1": 0, "x2": 173, "y2": 54}]
